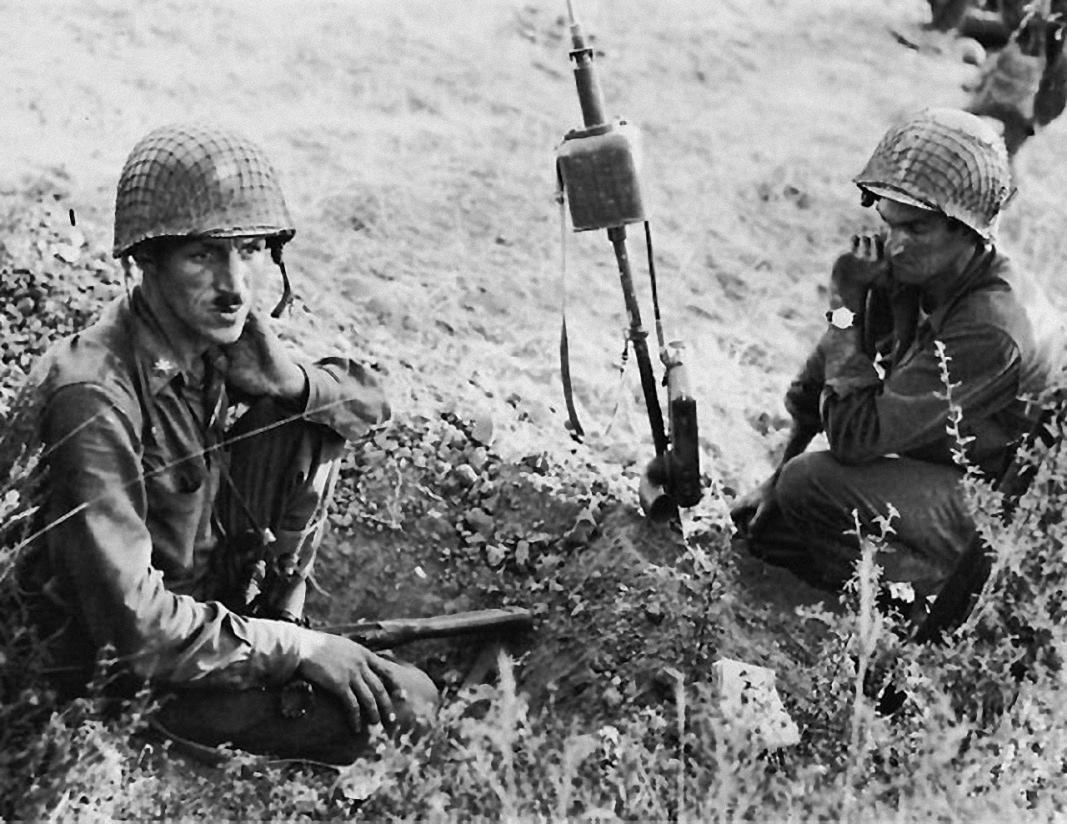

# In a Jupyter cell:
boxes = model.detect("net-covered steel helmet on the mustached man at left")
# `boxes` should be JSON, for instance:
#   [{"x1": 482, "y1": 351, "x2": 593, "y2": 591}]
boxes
[{"x1": 113, "y1": 124, "x2": 296, "y2": 257}]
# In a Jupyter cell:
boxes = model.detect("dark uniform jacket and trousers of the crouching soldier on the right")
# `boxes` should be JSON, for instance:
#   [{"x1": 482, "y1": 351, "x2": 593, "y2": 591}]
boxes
[{"x1": 752, "y1": 249, "x2": 1062, "y2": 591}]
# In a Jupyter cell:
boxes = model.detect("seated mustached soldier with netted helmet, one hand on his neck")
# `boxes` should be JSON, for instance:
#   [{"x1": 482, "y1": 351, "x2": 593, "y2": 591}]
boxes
[{"x1": 31, "y1": 125, "x2": 436, "y2": 762}]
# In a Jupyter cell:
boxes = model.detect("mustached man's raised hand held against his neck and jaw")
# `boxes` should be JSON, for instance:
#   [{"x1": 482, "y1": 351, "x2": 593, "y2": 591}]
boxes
[{"x1": 222, "y1": 312, "x2": 307, "y2": 400}]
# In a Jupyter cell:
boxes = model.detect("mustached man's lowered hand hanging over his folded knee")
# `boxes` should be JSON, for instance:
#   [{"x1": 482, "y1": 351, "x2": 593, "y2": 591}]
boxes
[{"x1": 298, "y1": 630, "x2": 396, "y2": 732}]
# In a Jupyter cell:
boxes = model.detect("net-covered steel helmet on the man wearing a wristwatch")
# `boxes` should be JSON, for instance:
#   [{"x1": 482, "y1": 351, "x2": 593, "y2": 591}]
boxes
[{"x1": 853, "y1": 109, "x2": 1015, "y2": 240}]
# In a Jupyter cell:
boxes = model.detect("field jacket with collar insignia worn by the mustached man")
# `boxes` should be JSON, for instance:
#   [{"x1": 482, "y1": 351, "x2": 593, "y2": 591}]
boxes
[{"x1": 28, "y1": 290, "x2": 389, "y2": 686}]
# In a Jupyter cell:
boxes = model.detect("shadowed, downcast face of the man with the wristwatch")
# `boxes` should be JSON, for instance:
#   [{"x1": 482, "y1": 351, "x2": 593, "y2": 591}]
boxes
[{"x1": 877, "y1": 197, "x2": 974, "y2": 286}]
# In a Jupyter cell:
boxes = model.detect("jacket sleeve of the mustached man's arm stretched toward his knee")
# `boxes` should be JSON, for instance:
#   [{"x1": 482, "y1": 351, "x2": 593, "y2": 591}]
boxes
[{"x1": 42, "y1": 383, "x2": 303, "y2": 686}]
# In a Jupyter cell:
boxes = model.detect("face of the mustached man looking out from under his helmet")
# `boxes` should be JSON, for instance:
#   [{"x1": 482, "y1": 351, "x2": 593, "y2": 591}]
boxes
[{"x1": 141, "y1": 238, "x2": 269, "y2": 349}]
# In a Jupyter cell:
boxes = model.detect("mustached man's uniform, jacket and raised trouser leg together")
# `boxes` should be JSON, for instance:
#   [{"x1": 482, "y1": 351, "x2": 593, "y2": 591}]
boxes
[{"x1": 29, "y1": 289, "x2": 389, "y2": 686}]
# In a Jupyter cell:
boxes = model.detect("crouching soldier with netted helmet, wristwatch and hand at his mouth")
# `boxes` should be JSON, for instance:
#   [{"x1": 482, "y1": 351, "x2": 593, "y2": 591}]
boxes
[{"x1": 732, "y1": 109, "x2": 1062, "y2": 617}]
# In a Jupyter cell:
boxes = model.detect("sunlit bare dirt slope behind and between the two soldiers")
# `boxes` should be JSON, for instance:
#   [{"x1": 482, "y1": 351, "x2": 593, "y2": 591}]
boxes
[{"x1": 6, "y1": 0, "x2": 1067, "y2": 813}]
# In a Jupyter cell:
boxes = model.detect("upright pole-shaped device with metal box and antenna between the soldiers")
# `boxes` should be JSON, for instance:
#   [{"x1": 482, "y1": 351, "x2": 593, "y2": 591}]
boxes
[{"x1": 556, "y1": 0, "x2": 702, "y2": 521}]
